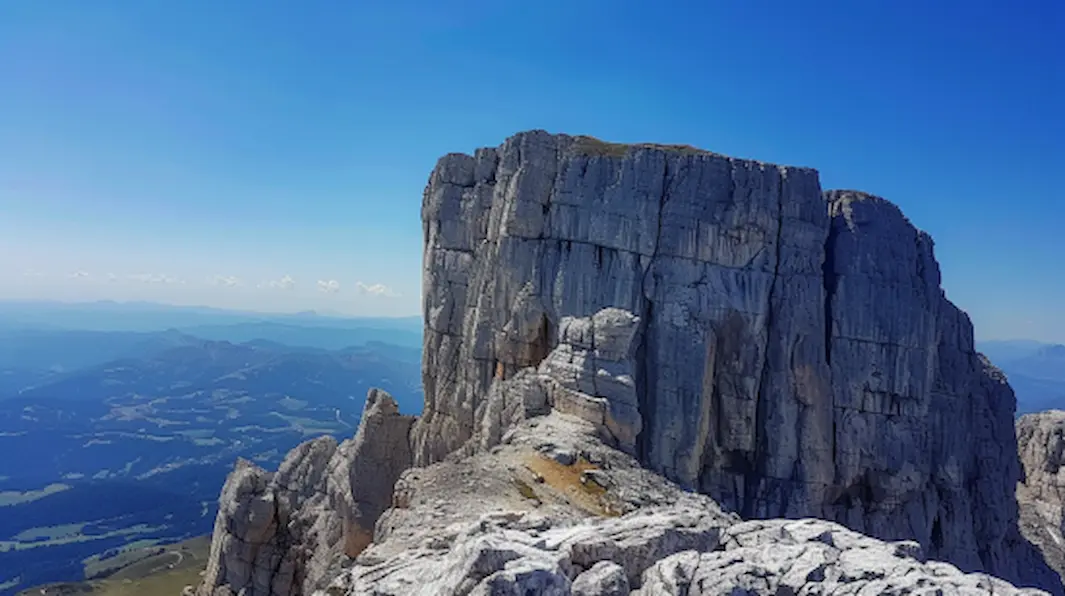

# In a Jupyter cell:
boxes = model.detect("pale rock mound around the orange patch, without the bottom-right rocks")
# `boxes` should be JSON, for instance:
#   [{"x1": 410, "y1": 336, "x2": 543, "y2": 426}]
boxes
[{"x1": 319, "y1": 412, "x2": 738, "y2": 596}]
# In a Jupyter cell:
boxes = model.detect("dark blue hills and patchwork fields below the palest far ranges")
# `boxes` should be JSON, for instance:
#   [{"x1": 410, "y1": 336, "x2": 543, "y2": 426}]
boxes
[{"x1": 0, "y1": 336, "x2": 422, "y2": 595}]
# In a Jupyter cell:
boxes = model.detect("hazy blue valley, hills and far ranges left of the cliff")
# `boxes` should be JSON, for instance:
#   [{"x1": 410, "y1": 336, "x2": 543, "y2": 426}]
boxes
[{"x1": 0, "y1": 308, "x2": 422, "y2": 594}]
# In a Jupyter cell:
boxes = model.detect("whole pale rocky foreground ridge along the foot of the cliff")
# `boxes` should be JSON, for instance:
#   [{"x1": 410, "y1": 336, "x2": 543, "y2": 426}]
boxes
[{"x1": 316, "y1": 414, "x2": 1042, "y2": 596}]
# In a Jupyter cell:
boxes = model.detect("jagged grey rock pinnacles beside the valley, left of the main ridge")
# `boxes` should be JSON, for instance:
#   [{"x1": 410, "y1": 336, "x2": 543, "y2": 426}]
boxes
[{"x1": 197, "y1": 390, "x2": 414, "y2": 596}]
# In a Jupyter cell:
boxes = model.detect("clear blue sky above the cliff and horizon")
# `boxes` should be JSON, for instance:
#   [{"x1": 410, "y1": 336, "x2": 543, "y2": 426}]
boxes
[{"x1": 0, "y1": 0, "x2": 1065, "y2": 341}]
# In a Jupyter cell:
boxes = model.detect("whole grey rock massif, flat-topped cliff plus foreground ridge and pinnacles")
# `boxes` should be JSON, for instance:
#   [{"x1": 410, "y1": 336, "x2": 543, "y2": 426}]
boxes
[{"x1": 195, "y1": 131, "x2": 1061, "y2": 596}]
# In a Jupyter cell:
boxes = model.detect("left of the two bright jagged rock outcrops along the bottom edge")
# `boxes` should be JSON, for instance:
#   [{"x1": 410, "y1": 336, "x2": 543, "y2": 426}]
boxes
[{"x1": 319, "y1": 508, "x2": 727, "y2": 596}]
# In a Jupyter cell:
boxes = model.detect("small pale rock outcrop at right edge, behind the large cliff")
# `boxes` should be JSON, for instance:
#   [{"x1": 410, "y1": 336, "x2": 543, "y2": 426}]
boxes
[{"x1": 1017, "y1": 410, "x2": 1065, "y2": 576}]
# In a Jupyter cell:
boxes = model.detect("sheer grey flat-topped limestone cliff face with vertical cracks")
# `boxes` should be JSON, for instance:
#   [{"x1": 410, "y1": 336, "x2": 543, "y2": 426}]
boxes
[{"x1": 412, "y1": 132, "x2": 1036, "y2": 579}]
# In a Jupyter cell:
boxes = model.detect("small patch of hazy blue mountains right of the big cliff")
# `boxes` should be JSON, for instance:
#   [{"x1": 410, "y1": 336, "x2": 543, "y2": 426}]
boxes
[{"x1": 977, "y1": 340, "x2": 1065, "y2": 416}]
